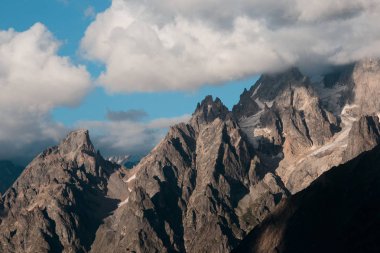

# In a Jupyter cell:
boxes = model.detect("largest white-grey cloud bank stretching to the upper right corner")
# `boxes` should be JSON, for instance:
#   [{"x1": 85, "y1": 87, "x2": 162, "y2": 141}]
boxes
[{"x1": 81, "y1": 0, "x2": 380, "y2": 92}]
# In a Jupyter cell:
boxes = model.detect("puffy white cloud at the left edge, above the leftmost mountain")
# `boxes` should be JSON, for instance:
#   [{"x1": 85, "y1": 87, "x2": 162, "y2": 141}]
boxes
[{"x1": 0, "y1": 23, "x2": 91, "y2": 162}]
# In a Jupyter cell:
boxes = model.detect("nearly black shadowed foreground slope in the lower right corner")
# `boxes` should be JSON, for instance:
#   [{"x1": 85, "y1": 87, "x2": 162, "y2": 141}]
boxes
[{"x1": 233, "y1": 146, "x2": 380, "y2": 253}]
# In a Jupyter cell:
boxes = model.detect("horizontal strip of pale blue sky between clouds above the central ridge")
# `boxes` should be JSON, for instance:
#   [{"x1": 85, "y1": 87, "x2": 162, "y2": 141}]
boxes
[{"x1": 53, "y1": 78, "x2": 255, "y2": 126}]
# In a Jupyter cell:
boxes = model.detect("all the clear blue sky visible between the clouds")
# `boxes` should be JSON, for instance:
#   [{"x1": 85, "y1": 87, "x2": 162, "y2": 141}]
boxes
[{"x1": 0, "y1": 0, "x2": 256, "y2": 126}]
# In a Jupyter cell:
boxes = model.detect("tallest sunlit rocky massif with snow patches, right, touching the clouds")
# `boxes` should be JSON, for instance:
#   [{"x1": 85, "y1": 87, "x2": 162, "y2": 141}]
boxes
[{"x1": 233, "y1": 60, "x2": 380, "y2": 193}]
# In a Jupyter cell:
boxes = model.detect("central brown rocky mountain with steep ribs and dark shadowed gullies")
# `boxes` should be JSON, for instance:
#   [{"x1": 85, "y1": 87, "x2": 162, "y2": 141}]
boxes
[{"x1": 92, "y1": 97, "x2": 287, "y2": 252}]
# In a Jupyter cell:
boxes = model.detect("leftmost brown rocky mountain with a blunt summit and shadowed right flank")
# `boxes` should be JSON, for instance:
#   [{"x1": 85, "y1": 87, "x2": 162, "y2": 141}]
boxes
[{"x1": 0, "y1": 130, "x2": 127, "y2": 252}]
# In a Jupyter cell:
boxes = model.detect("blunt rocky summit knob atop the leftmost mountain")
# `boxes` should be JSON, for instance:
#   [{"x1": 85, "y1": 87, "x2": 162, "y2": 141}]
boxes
[{"x1": 58, "y1": 129, "x2": 95, "y2": 154}]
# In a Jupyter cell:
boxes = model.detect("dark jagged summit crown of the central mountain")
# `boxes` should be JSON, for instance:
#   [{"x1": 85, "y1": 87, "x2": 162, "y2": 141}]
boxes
[{"x1": 191, "y1": 95, "x2": 230, "y2": 125}]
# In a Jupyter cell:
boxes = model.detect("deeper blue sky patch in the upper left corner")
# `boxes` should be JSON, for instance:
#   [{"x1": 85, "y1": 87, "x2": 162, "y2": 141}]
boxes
[{"x1": 0, "y1": 0, "x2": 111, "y2": 57}]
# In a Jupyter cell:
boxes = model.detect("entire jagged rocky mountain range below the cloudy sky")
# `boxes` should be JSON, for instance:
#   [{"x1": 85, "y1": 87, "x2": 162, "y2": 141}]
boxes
[{"x1": 0, "y1": 59, "x2": 380, "y2": 253}]
